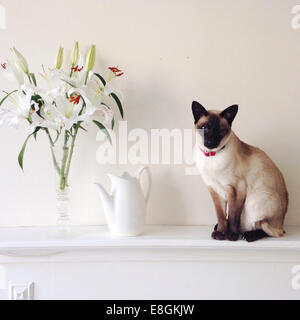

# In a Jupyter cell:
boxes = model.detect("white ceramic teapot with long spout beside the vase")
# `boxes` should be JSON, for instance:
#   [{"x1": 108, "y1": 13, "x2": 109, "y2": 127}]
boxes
[{"x1": 96, "y1": 166, "x2": 151, "y2": 236}]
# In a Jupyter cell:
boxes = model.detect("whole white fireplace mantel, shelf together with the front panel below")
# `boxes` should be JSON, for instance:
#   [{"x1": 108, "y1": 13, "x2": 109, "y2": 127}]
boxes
[{"x1": 0, "y1": 225, "x2": 300, "y2": 299}]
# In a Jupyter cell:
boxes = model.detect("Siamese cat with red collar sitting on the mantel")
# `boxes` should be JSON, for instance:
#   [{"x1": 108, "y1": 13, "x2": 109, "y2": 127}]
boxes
[{"x1": 192, "y1": 101, "x2": 288, "y2": 241}]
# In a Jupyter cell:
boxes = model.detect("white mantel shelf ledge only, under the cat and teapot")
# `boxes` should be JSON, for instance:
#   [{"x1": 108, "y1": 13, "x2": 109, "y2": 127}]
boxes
[{"x1": 0, "y1": 225, "x2": 300, "y2": 263}]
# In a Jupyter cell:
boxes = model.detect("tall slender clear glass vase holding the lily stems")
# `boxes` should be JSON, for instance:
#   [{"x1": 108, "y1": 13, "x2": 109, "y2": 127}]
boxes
[{"x1": 51, "y1": 131, "x2": 74, "y2": 231}]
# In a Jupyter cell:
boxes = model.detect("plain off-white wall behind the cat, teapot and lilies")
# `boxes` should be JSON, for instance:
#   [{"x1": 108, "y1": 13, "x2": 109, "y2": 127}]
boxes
[{"x1": 0, "y1": 0, "x2": 300, "y2": 225}]
